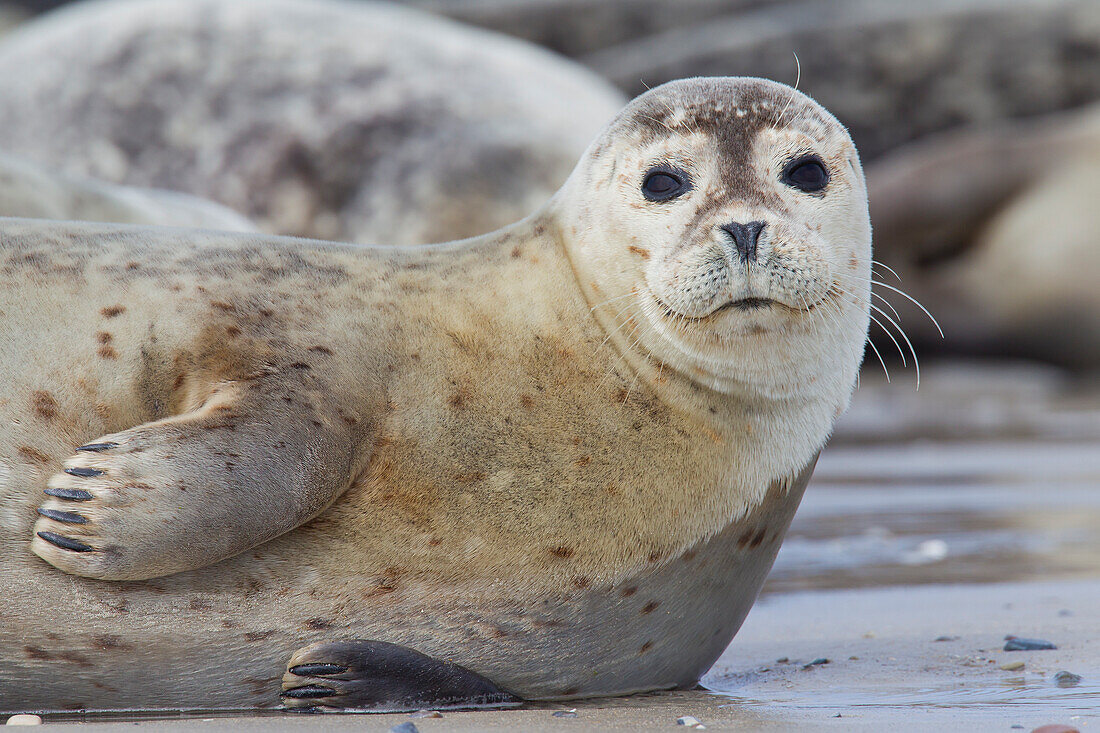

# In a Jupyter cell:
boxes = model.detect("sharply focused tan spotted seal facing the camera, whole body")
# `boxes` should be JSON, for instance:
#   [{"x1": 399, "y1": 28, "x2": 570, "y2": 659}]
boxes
[{"x1": 0, "y1": 78, "x2": 870, "y2": 710}]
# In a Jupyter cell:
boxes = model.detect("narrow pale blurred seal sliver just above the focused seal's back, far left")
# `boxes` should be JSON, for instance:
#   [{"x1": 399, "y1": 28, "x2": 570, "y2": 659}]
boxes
[{"x1": 0, "y1": 153, "x2": 257, "y2": 231}]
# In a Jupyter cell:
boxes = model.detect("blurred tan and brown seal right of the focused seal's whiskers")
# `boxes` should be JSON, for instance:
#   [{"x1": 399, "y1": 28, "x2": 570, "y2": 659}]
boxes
[{"x1": 868, "y1": 107, "x2": 1100, "y2": 368}]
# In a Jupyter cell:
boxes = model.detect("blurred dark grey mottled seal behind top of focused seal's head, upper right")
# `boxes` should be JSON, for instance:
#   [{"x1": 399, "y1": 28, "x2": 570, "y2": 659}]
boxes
[{"x1": 580, "y1": 0, "x2": 1100, "y2": 161}]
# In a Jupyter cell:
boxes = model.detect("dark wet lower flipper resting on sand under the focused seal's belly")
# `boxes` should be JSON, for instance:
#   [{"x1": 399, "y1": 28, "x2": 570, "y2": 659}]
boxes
[{"x1": 282, "y1": 639, "x2": 524, "y2": 712}]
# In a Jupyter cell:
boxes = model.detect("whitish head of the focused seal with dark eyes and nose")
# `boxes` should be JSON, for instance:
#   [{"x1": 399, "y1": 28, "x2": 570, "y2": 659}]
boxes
[{"x1": 560, "y1": 78, "x2": 871, "y2": 408}]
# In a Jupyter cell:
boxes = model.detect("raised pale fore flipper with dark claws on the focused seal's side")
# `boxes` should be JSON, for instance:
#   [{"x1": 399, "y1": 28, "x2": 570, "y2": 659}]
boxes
[{"x1": 31, "y1": 369, "x2": 360, "y2": 580}]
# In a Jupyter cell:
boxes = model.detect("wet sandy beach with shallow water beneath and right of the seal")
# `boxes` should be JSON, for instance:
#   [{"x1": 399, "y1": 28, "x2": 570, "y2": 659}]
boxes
[{"x1": 15, "y1": 362, "x2": 1100, "y2": 732}]
